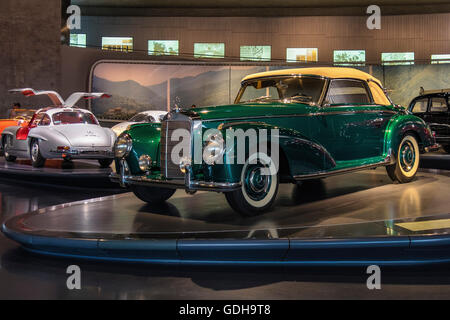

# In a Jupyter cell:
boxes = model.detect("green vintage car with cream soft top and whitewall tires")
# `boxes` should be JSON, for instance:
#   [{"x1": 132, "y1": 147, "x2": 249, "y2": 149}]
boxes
[{"x1": 111, "y1": 68, "x2": 439, "y2": 216}]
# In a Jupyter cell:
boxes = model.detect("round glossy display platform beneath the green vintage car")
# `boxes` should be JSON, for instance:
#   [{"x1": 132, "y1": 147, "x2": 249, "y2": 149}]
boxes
[{"x1": 3, "y1": 168, "x2": 450, "y2": 265}]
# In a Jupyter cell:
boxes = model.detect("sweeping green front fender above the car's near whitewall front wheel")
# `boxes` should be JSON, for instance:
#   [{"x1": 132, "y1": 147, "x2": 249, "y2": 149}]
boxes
[{"x1": 206, "y1": 121, "x2": 336, "y2": 182}]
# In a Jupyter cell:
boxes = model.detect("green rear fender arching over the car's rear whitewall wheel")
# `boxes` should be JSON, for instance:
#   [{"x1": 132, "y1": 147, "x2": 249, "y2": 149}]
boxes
[{"x1": 384, "y1": 114, "x2": 434, "y2": 159}]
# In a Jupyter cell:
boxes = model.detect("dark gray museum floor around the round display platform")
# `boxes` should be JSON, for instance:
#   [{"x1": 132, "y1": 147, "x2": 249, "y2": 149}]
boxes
[{"x1": 0, "y1": 171, "x2": 450, "y2": 299}]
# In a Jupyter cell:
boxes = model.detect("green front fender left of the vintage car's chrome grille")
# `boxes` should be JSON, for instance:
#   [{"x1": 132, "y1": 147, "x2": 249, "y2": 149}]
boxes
[{"x1": 123, "y1": 123, "x2": 161, "y2": 174}]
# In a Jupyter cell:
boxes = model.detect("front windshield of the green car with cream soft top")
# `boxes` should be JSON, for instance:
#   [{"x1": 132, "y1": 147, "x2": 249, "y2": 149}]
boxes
[{"x1": 236, "y1": 76, "x2": 325, "y2": 104}]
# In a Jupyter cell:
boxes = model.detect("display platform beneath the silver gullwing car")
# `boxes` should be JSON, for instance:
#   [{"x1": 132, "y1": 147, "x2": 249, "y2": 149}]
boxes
[{"x1": 0, "y1": 157, "x2": 119, "y2": 189}]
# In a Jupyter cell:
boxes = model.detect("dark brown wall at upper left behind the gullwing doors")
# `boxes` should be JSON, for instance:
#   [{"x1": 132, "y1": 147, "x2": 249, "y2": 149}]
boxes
[{"x1": 0, "y1": 0, "x2": 61, "y2": 117}]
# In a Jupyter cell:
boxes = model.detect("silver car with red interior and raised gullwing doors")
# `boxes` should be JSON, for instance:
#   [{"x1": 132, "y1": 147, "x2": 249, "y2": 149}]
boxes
[{"x1": 1, "y1": 88, "x2": 116, "y2": 167}]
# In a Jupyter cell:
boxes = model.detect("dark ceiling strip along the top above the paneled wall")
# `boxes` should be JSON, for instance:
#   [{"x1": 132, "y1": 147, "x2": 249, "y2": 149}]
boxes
[{"x1": 71, "y1": 0, "x2": 450, "y2": 16}]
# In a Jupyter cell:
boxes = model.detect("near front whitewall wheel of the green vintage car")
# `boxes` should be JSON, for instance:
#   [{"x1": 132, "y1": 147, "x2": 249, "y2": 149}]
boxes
[{"x1": 225, "y1": 153, "x2": 279, "y2": 217}]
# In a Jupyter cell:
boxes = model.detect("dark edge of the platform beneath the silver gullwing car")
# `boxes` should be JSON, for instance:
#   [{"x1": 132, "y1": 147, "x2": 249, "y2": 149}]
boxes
[{"x1": 0, "y1": 167, "x2": 120, "y2": 190}]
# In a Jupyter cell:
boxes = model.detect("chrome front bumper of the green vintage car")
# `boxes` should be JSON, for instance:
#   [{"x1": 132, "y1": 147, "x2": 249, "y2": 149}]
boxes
[{"x1": 110, "y1": 161, "x2": 241, "y2": 192}]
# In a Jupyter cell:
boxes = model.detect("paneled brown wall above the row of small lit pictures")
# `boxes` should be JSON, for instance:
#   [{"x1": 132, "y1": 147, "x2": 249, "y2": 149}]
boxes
[{"x1": 76, "y1": 13, "x2": 450, "y2": 63}]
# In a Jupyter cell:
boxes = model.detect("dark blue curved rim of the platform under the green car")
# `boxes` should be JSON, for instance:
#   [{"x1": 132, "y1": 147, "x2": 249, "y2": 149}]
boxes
[{"x1": 2, "y1": 222, "x2": 450, "y2": 266}]
